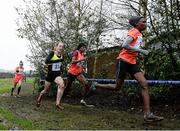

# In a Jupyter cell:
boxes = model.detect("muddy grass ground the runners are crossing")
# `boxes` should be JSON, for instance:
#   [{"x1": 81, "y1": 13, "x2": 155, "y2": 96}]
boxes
[{"x1": 0, "y1": 78, "x2": 180, "y2": 130}]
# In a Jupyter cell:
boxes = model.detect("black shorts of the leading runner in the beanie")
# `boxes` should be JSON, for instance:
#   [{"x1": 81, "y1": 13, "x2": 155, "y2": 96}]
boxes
[{"x1": 116, "y1": 59, "x2": 141, "y2": 79}]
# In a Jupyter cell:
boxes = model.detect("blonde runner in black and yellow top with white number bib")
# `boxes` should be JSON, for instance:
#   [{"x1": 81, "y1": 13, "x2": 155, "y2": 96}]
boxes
[{"x1": 37, "y1": 42, "x2": 65, "y2": 110}]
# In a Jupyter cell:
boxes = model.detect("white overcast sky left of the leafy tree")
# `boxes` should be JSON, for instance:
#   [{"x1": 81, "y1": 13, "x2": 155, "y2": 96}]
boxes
[{"x1": 0, "y1": 0, "x2": 31, "y2": 70}]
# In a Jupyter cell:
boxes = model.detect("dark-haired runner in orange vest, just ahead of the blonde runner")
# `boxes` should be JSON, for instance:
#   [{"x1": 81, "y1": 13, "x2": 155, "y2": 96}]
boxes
[{"x1": 65, "y1": 42, "x2": 93, "y2": 107}]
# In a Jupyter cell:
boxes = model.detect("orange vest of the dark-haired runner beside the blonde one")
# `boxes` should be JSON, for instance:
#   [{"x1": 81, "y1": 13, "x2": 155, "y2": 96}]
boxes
[{"x1": 68, "y1": 50, "x2": 84, "y2": 75}]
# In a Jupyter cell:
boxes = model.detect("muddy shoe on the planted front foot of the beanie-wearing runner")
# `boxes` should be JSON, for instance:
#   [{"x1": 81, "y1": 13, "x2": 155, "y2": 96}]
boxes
[{"x1": 144, "y1": 113, "x2": 164, "y2": 122}]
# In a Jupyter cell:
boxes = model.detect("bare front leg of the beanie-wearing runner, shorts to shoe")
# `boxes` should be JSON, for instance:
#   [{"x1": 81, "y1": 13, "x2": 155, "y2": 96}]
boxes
[{"x1": 134, "y1": 72, "x2": 150, "y2": 113}]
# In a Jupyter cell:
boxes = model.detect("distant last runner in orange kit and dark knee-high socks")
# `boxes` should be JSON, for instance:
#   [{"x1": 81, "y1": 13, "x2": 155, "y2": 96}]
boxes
[{"x1": 11, "y1": 61, "x2": 25, "y2": 97}]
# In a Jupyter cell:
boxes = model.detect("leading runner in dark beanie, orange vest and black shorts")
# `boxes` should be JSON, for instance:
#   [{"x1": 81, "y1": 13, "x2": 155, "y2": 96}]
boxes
[{"x1": 91, "y1": 16, "x2": 164, "y2": 122}]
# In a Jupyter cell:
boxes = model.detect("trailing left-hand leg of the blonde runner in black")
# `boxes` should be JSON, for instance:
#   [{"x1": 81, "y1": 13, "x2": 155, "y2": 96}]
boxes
[{"x1": 37, "y1": 81, "x2": 50, "y2": 107}]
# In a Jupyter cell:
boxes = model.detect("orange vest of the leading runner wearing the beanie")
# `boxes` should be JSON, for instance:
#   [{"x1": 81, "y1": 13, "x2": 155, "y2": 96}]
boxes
[{"x1": 117, "y1": 28, "x2": 142, "y2": 64}]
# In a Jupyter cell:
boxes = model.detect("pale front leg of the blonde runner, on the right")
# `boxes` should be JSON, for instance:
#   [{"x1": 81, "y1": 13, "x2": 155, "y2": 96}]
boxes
[{"x1": 55, "y1": 76, "x2": 65, "y2": 110}]
